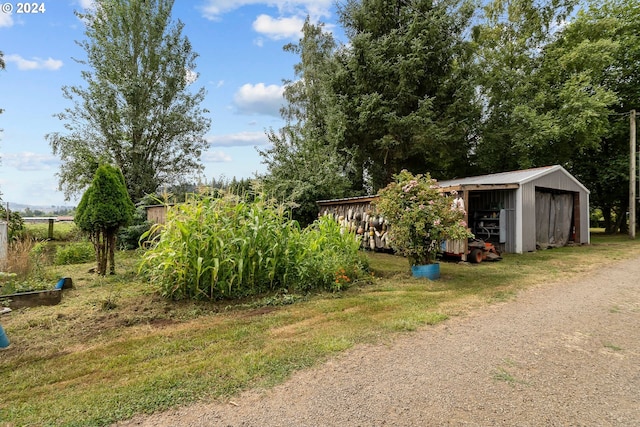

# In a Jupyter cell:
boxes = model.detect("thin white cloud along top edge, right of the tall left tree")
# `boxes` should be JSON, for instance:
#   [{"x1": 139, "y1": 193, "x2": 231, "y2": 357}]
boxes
[{"x1": 201, "y1": 0, "x2": 334, "y2": 21}]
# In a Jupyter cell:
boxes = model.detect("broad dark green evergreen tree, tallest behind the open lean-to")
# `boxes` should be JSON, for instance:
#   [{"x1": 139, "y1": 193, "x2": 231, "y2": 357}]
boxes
[{"x1": 328, "y1": 0, "x2": 480, "y2": 192}]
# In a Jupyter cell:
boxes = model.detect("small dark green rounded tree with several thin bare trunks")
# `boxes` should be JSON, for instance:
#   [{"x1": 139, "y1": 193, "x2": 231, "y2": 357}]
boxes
[{"x1": 74, "y1": 164, "x2": 135, "y2": 276}]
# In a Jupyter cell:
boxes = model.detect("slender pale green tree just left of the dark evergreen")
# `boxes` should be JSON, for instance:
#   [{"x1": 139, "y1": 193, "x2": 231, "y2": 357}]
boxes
[{"x1": 260, "y1": 19, "x2": 351, "y2": 225}]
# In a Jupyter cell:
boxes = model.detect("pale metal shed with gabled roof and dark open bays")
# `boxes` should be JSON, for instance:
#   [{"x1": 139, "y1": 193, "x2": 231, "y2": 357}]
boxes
[{"x1": 439, "y1": 165, "x2": 590, "y2": 253}]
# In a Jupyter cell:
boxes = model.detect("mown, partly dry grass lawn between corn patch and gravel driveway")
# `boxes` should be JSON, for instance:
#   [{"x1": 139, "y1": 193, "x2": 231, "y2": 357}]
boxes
[{"x1": 0, "y1": 235, "x2": 640, "y2": 426}]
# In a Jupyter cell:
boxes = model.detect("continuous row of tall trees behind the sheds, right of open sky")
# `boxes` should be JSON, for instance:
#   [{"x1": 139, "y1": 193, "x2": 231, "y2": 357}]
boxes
[{"x1": 261, "y1": 0, "x2": 640, "y2": 231}]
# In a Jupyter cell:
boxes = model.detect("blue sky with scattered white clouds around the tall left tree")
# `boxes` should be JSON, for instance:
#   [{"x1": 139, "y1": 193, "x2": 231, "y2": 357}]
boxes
[{"x1": 0, "y1": 0, "x2": 337, "y2": 206}]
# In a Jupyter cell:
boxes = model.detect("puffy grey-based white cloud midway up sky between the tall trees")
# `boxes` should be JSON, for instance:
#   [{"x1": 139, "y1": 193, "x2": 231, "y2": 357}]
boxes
[{"x1": 233, "y1": 83, "x2": 284, "y2": 117}]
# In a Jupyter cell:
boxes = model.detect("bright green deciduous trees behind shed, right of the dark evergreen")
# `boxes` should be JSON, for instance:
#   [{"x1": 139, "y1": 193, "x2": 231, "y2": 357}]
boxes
[{"x1": 474, "y1": 0, "x2": 640, "y2": 231}]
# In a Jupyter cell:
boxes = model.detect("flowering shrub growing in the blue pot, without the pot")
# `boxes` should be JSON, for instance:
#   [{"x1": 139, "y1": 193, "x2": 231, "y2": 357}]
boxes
[{"x1": 374, "y1": 170, "x2": 473, "y2": 265}]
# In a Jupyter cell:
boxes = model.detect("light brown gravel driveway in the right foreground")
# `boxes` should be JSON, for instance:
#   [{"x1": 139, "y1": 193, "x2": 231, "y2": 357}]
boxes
[{"x1": 118, "y1": 258, "x2": 640, "y2": 427}]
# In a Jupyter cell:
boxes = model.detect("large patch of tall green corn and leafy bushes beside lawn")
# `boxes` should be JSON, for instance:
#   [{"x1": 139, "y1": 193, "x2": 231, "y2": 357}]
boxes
[{"x1": 140, "y1": 196, "x2": 366, "y2": 299}]
